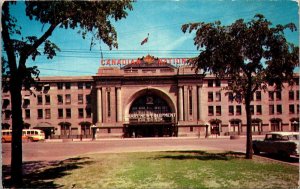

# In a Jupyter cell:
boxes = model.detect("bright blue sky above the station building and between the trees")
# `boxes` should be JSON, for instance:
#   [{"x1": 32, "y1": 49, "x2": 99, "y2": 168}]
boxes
[{"x1": 2, "y1": 0, "x2": 299, "y2": 76}]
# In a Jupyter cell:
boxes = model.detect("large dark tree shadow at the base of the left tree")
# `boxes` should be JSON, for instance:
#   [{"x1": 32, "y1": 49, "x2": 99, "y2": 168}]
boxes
[{"x1": 2, "y1": 157, "x2": 92, "y2": 188}]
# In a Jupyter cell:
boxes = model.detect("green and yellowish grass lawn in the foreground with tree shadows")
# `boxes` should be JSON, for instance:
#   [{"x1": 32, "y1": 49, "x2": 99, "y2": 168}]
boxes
[{"x1": 18, "y1": 151, "x2": 299, "y2": 189}]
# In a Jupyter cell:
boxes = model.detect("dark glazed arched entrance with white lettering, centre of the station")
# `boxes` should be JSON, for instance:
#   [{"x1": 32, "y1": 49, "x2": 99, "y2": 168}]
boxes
[{"x1": 124, "y1": 91, "x2": 177, "y2": 137}]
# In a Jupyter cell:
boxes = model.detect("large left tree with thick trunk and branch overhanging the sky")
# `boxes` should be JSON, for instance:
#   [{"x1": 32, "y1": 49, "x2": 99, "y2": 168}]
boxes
[{"x1": 1, "y1": 0, "x2": 132, "y2": 187}]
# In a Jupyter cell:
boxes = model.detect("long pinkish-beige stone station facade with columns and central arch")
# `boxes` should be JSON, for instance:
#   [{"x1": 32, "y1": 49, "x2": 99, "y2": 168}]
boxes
[{"x1": 2, "y1": 56, "x2": 299, "y2": 138}]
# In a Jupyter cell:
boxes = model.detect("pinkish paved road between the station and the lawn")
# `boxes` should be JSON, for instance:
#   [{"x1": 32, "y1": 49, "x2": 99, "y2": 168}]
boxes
[{"x1": 2, "y1": 137, "x2": 299, "y2": 165}]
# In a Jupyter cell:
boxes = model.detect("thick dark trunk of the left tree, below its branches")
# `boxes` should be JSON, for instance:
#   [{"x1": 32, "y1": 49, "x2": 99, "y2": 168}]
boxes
[{"x1": 10, "y1": 75, "x2": 23, "y2": 187}]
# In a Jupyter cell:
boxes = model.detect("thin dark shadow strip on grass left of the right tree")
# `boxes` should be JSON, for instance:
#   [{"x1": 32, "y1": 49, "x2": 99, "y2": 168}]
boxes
[{"x1": 154, "y1": 151, "x2": 245, "y2": 161}]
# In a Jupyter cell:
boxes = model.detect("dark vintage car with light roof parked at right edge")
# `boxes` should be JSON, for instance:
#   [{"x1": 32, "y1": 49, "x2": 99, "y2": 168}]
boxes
[{"x1": 252, "y1": 132, "x2": 299, "y2": 157}]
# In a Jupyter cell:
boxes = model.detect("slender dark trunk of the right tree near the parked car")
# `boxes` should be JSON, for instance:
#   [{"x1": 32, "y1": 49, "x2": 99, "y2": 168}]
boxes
[{"x1": 245, "y1": 81, "x2": 253, "y2": 159}]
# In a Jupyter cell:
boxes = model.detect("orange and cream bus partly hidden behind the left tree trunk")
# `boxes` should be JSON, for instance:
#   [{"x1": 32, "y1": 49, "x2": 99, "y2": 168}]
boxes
[{"x1": 1, "y1": 129, "x2": 45, "y2": 142}]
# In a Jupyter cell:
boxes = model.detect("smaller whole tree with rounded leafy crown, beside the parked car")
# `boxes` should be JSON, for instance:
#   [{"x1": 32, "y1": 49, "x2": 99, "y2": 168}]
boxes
[{"x1": 182, "y1": 14, "x2": 299, "y2": 159}]
